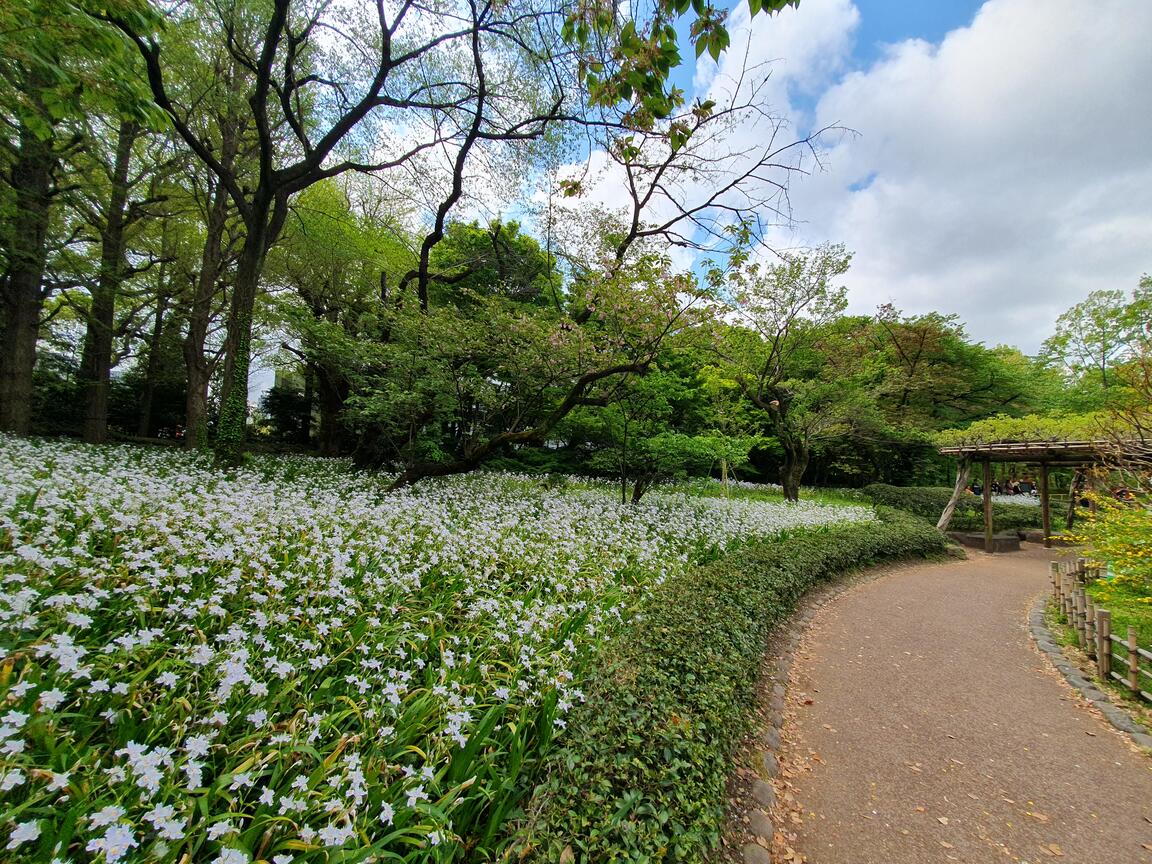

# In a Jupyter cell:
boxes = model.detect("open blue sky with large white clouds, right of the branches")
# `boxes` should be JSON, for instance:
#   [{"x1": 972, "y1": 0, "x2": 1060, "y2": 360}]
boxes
[{"x1": 677, "y1": 0, "x2": 1152, "y2": 354}]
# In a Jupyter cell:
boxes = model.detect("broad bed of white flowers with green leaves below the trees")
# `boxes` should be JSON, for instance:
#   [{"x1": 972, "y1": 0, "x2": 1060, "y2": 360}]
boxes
[{"x1": 0, "y1": 438, "x2": 871, "y2": 864}]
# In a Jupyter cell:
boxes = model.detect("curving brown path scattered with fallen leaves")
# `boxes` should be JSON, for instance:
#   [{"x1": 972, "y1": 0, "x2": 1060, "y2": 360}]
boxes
[{"x1": 785, "y1": 548, "x2": 1152, "y2": 864}]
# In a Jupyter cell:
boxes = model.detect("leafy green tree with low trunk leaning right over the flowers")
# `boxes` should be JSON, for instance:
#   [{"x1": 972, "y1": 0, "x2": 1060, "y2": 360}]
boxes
[{"x1": 349, "y1": 249, "x2": 704, "y2": 486}]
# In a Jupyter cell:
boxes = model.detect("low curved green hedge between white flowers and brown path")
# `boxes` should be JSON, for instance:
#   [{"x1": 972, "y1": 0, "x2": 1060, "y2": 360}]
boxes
[{"x1": 517, "y1": 508, "x2": 946, "y2": 864}]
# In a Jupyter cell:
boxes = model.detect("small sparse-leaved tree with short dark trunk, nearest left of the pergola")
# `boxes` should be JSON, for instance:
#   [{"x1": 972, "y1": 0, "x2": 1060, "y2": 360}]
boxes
[{"x1": 718, "y1": 245, "x2": 851, "y2": 501}]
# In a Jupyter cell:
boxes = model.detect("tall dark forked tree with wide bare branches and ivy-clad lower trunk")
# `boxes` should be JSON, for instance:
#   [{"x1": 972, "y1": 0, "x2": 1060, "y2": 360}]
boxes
[{"x1": 100, "y1": 0, "x2": 580, "y2": 462}]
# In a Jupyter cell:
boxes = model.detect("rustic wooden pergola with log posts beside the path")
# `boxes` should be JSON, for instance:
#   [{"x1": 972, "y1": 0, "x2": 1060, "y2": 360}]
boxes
[{"x1": 938, "y1": 440, "x2": 1115, "y2": 552}]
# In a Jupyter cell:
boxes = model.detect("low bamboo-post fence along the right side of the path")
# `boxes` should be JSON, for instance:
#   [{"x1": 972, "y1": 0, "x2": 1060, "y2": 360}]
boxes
[{"x1": 1052, "y1": 558, "x2": 1152, "y2": 702}]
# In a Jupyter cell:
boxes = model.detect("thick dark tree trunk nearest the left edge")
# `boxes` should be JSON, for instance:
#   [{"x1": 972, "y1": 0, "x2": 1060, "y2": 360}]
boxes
[{"x1": 0, "y1": 103, "x2": 56, "y2": 435}]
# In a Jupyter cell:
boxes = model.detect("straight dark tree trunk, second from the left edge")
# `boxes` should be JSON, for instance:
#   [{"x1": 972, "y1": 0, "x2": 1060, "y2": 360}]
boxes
[{"x1": 81, "y1": 121, "x2": 139, "y2": 444}]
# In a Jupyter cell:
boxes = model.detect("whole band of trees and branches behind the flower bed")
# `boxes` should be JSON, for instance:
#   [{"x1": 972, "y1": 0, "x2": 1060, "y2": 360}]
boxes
[{"x1": 0, "y1": 0, "x2": 1150, "y2": 499}]
